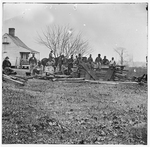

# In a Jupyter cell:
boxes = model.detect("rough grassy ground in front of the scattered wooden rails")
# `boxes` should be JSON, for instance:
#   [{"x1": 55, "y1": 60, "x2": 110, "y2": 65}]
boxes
[{"x1": 2, "y1": 79, "x2": 148, "y2": 144}]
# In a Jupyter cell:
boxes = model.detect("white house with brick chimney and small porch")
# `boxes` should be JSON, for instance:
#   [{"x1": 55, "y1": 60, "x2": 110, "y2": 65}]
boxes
[{"x1": 2, "y1": 28, "x2": 40, "y2": 68}]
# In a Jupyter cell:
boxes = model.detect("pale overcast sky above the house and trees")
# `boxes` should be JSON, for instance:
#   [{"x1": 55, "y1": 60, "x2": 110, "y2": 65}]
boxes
[{"x1": 3, "y1": 3, "x2": 148, "y2": 62}]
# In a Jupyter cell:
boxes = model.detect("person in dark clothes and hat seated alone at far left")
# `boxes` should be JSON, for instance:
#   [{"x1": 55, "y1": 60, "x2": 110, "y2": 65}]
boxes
[{"x1": 2, "y1": 57, "x2": 17, "y2": 75}]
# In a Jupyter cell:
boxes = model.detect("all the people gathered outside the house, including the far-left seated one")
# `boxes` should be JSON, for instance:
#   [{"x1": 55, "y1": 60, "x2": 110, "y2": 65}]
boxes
[{"x1": 3, "y1": 51, "x2": 116, "y2": 75}]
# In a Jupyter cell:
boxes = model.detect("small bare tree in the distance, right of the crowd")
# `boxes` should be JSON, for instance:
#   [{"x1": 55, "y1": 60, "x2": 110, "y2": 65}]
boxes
[{"x1": 114, "y1": 47, "x2": 128, "y2": 65}]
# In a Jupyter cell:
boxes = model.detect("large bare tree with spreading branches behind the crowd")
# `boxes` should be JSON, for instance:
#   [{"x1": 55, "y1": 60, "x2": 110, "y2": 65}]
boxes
[{"x1": 36, "y1": 25, "x2": 90, "y2": 57}]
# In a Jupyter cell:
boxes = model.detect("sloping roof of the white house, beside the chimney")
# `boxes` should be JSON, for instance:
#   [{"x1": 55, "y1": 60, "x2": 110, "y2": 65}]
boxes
[{"x1": 7, "y1": 34, "x2": 39, "y2": 53}]
